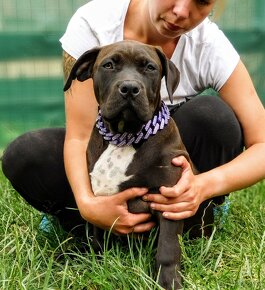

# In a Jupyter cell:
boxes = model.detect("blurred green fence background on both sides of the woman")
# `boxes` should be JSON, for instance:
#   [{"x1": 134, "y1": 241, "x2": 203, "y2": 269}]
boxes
[{"x1": 0, "y1": 0, "x2": 265, "y2": 149}]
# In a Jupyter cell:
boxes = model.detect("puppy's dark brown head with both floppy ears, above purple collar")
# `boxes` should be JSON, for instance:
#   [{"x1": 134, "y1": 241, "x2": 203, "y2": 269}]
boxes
[{"x1": 64, "y1": 41, "x2": 179, "y2": 133}]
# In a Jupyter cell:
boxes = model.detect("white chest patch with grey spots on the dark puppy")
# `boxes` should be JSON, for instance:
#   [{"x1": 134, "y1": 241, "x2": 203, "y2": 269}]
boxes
[{"x1": 90, "y1": 144, "x2": 136, "y2": 195}]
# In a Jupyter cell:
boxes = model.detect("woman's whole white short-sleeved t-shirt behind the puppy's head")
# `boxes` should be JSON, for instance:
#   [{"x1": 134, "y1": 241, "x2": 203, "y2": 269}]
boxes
[{"x1": 60, "y1": 0, "x2": 239, "y2": 104}]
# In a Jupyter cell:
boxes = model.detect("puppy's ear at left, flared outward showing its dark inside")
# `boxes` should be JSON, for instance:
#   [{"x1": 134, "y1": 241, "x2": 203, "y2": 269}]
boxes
[{"x1": 63, "y1": 47, "x2": 100, "y2": 91}]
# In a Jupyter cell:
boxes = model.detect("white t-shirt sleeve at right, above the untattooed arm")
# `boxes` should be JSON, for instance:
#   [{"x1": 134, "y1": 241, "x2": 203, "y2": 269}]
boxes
[{"x1": 200, "y1": 29, "x2": 240, "y2": 92}]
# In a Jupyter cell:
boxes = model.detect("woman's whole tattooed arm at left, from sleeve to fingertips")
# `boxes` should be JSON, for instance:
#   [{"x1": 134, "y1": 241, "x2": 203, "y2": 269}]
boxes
[{"x1": 63, "y1": 52, "x2": 154, "y2": 233}]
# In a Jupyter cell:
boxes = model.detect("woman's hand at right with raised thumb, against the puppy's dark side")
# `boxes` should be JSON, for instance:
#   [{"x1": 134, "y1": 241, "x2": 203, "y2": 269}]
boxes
[{"x1": 143, "y1": 156, "x2": 204, "y2": 220}]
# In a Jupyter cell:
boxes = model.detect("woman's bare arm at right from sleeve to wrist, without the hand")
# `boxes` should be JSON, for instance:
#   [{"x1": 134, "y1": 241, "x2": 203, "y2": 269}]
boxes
[{"x1": 197, "y1": 61, "x2": 265, "y2": 197}]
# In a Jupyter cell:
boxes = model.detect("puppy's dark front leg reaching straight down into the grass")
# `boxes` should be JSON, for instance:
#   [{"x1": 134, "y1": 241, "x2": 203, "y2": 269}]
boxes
[{"x1": 156, "y1": 213, "x2": 183, "y2": 290}]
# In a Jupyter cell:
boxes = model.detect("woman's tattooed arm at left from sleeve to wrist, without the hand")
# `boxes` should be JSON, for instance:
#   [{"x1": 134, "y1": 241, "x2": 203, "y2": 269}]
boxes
[{"x1": 63, "y1": 52, "x2": 98, "y2": 204}]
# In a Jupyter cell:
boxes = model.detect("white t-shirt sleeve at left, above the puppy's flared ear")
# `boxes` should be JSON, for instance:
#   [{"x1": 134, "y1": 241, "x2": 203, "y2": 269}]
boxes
[{"x1": 60, "y1": 9, "x2": 99, "y2": 59}]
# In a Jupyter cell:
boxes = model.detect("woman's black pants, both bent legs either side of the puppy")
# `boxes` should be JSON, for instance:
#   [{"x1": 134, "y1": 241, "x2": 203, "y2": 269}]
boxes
[{"x1": 2, "y1": 96, "x2": 243, "y2": 230}]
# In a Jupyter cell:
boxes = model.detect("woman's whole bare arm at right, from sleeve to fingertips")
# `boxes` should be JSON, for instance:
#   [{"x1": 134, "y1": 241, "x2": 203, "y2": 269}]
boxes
[{"x1": 145, "y1": 61, "x2": 265, "y2": 220}]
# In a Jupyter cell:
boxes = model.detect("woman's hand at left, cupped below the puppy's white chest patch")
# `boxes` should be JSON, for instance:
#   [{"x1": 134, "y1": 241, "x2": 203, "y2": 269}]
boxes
[{"x1": 79, "y1": 188, "x2": 155, "y2": 234}]
